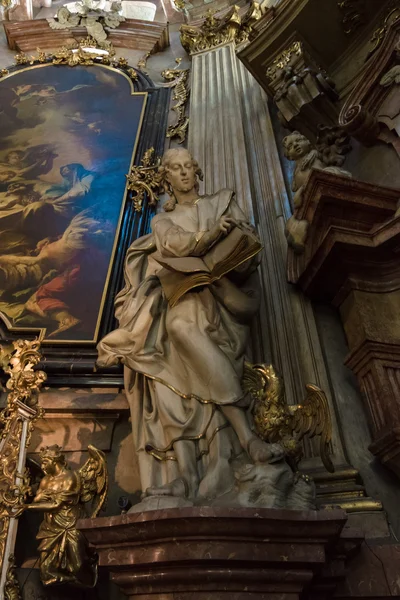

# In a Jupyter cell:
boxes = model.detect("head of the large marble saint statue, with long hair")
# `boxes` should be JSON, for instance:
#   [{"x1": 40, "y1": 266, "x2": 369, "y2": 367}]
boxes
[{"x1": 159, "y1": 148, "x2": 203, "y2": 211}]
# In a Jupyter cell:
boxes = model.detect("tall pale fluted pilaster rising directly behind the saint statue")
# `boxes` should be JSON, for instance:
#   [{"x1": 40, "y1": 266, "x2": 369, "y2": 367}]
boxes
[{"x1": 189, "y1": 43, "x2": 343, "y2": 461}]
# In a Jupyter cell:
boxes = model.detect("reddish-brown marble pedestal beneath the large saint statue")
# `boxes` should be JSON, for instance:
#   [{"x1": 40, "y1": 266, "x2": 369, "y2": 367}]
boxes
[{"x1": 78, "y1": 507, "x2": 361, "y2": 600}]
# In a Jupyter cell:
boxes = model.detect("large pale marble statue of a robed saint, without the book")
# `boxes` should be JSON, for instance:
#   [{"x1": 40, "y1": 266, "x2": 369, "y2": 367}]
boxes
[{"x1": 98, "y1": 148, "x2": 282, "y2": 503}]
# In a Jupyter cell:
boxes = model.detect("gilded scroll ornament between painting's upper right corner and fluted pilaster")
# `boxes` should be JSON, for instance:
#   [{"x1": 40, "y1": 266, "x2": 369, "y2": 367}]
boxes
[{"x1": 161, "y1": 58, "x2": 190, "y2": 144}]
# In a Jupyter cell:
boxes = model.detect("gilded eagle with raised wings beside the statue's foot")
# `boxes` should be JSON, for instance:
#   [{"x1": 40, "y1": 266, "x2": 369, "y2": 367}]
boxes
[{"x1": 243, "y1": 363, "x2": 335, "y2": 473}]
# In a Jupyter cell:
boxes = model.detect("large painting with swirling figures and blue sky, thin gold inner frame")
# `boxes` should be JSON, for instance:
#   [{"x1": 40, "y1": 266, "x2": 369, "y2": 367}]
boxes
[{"x1": 0, "y1": 62, "x2": 147, "y2": 344}]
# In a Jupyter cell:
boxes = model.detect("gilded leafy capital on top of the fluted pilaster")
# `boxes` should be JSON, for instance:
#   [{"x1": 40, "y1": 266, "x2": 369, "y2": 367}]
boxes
[{"x1": 180, "y1": 2, "x2": 261, "y2": 54}]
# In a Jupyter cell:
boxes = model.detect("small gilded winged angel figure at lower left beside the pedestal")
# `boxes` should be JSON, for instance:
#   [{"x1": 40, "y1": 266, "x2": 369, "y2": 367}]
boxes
[{"x1": 26, "y1": 445, "x2": 108, "y2": 587}]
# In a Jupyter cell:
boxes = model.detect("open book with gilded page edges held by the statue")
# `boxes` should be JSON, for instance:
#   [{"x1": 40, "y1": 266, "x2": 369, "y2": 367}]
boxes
[{"x1": 153, "y1": 226, "x2": 262, "y2": 306}]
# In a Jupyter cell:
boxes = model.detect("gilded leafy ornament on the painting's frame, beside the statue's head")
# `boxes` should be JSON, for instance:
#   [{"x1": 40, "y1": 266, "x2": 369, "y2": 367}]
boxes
[{"x1": 126, "y1": 148, "x2": 161, "y2": 212}]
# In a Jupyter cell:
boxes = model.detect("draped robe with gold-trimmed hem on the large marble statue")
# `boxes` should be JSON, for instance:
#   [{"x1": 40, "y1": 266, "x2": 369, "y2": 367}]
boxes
[{"x1": 98, "y1": 190, "x2": 258, "y2": 498}]
